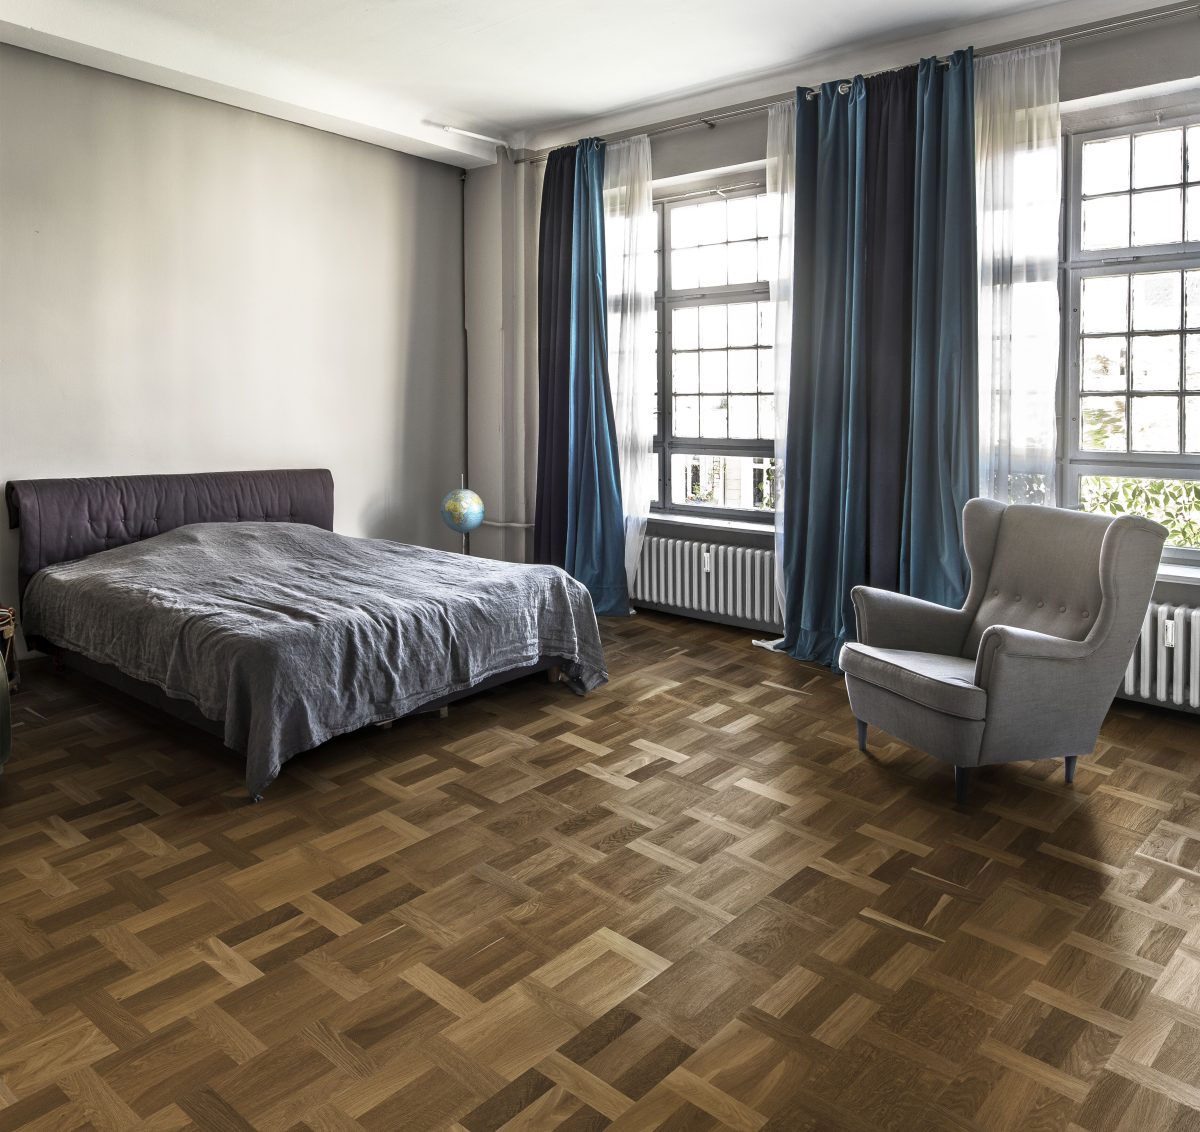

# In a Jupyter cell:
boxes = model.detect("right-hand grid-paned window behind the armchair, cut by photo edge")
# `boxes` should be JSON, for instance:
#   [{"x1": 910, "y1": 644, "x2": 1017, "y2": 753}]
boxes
[{"x1": 1063, "y1": 116, "x2": 1200, "y2": 561}]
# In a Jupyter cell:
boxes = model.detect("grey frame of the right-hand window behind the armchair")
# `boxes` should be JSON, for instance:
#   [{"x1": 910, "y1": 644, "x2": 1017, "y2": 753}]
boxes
[{"x1": 1058, "y1": 112, "x2": 1200, "y2": 567}]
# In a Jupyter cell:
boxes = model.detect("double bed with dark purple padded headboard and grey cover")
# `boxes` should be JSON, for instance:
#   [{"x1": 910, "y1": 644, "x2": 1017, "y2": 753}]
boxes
[{"x1": 5, "y1": 469, "x2": 607, "y2": 801}]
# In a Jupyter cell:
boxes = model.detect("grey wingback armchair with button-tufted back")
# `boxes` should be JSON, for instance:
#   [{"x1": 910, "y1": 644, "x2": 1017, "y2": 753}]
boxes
[{"x1": 839, "y1": 499, "x2": 1166, "y2": 802}]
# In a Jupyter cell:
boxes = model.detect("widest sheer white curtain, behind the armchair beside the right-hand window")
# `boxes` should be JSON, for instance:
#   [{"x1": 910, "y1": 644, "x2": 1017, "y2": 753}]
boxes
[{"x1": 974, "y1": 42, "x2": 1062, "y2": 504}]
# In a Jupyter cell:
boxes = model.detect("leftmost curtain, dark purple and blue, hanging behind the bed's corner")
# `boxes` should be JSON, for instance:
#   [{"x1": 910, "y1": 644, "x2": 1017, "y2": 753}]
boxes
[{"x1": 534, "y1": 138, "x2": 629, "y2": 615}]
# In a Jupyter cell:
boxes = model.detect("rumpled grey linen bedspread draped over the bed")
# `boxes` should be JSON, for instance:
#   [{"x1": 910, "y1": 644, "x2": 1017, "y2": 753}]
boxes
[{"x1": 24, "y1": 522, "x2": 608, "y2": 797}]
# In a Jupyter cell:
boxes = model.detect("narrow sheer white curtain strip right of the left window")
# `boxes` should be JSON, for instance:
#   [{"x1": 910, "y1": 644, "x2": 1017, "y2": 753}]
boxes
[{"x1": 767, "y1": 98, "x2": 796, "y2": 606}]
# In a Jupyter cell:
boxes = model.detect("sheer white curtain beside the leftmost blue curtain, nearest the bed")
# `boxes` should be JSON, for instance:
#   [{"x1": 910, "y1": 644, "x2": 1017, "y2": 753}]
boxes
[{"x1": 604, "y1": 133, "x2": 658, "y2": 588}]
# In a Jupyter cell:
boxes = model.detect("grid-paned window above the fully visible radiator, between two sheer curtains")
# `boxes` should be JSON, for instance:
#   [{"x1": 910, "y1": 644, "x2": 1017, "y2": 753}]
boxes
[{"x1": 655, "y1": 185, "x2": 775, "y2": 521}]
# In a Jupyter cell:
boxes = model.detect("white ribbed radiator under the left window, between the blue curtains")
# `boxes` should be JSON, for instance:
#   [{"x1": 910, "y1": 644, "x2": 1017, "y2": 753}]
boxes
[{"x1": 632, "y1": 537, "x2": 784, "y2": 633}]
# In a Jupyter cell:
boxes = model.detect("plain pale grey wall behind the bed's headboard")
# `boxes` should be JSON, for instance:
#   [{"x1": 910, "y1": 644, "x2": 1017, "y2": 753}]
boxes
[{"x1": 0, "y1": 46, "x2": 462, "y2": 629}]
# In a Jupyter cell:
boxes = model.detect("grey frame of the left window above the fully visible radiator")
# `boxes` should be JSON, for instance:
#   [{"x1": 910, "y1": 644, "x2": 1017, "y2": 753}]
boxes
[{"x1": 650, "y1": 182, "x2": 775, "y2": 526}]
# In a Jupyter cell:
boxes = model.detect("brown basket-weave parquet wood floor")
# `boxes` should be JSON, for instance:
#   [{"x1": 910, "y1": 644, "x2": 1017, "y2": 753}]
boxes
[{"x1": 0, "y1": 615, "x2": 1200, "y2": 1132}]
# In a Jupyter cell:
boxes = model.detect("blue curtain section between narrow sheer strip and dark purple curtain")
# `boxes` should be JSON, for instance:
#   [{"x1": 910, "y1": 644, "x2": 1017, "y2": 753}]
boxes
[{"x1": 776, "y1": 78, "x2": 868, "y2": 665}]
